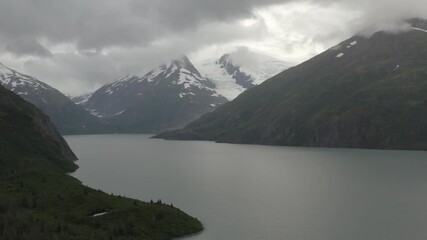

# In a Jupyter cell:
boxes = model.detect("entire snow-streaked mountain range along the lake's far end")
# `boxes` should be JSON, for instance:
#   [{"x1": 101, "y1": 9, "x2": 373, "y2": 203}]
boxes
[{"x1": 0, "y1": 49, "x2": 286, "y2": 134}]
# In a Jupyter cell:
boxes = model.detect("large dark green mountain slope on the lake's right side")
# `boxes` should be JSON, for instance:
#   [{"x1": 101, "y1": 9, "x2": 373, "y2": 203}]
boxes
[{"x1": 159, "y1": 28, "x2": 427, "y2": 150}]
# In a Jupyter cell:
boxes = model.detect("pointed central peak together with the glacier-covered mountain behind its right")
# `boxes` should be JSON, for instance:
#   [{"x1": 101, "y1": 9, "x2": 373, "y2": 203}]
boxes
[{"x1": 71, "y1": 50, "x2": 288, "y2": 133}]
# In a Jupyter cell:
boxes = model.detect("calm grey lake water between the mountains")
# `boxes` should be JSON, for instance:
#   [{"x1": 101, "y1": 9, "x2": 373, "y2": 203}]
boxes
[{"x1": 66, "y1": 135, "x2": 427, "y2": 240}]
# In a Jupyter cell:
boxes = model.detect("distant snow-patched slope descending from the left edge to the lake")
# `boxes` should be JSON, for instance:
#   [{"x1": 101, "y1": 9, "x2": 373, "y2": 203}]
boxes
[{"x1": 0, "y1": 63, "x2": 117, "y2": 134}]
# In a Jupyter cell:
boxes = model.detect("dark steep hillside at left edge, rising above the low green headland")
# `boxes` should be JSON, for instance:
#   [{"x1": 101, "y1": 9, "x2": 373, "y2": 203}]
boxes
[{"x1": 0, "y1": 86, "x2": 77, "y2": 171}]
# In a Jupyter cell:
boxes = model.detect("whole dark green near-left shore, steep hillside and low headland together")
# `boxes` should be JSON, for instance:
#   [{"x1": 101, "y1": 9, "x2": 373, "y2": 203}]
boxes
[{"x1": 0, "y1": 87, "x2": 202, "y2": 240}]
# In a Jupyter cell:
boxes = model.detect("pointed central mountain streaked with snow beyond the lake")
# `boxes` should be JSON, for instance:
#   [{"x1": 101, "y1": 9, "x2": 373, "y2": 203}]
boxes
[{"x1": 84, "y1": 56, "x2": 227, "y2": 133}]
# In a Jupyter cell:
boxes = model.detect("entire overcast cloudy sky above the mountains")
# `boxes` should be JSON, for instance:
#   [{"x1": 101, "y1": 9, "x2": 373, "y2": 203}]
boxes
[{"x1": 0, "y1": 0, "x2": 427, "y2": 95}]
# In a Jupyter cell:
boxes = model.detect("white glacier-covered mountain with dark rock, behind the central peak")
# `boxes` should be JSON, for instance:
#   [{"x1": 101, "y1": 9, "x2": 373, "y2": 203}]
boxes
[{"x1": 197, "y1": 48, "x2": 289, "y2": 100}]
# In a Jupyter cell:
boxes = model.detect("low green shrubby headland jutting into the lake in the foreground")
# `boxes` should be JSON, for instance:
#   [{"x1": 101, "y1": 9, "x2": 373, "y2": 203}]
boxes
[{"x1": 0, "y1": 156, "x2": 202, "y2": 240}]
